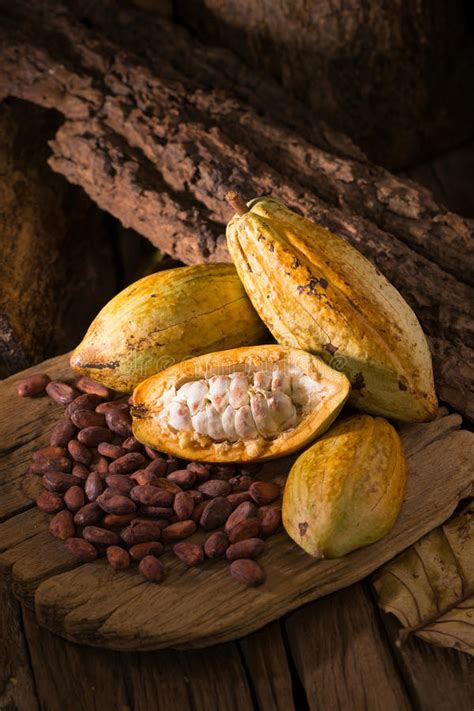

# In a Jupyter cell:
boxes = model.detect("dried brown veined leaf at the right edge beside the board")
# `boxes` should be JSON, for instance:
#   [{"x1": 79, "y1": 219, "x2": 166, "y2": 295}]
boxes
[{"x1": 373, "y1": 501, "x2": 474, "y2": 655}]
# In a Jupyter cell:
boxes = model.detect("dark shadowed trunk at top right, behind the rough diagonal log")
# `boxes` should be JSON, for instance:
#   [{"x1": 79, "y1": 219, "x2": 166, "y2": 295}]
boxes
[{"x1": 174, "y1": 0, "x2": 474, "y2": 170}]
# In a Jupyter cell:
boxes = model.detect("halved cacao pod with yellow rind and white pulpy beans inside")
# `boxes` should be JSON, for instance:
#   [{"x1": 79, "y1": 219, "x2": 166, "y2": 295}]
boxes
[{"x1": 132, "y1": 345, "x2": 350, "y2": 462}]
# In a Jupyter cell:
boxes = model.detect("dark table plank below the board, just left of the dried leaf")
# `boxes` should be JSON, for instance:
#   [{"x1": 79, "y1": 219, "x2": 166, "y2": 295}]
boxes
[{"x1": 285, "y1": 583, "x2": 412, "y2": 711}]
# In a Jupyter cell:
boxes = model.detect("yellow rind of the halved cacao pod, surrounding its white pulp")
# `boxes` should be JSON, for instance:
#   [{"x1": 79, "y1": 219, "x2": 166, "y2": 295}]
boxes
[{"x1": 132, "y1": 345, "x2": 350, "y2": 462}]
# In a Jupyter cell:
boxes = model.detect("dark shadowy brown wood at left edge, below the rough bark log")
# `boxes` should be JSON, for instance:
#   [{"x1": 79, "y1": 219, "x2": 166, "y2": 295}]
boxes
[{"x1": 0, "y1": 100, "x2": 117, "y2": 375}]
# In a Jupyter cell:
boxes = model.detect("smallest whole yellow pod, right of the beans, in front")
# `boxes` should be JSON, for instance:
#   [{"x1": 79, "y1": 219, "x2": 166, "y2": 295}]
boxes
[{"x1": 282, "y1": 415, "x2": 407, "y2": 558}]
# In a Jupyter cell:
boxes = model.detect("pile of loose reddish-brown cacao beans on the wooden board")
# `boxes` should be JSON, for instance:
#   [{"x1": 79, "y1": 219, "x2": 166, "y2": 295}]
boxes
[{"x1": 17, "y1": 374, "x2": 281, "y2": 586}]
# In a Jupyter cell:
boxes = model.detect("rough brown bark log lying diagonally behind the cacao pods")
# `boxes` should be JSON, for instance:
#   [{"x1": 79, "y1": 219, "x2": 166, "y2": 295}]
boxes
[{"x1": 0, "y1": 0, "x2": 474, "y2": 416}]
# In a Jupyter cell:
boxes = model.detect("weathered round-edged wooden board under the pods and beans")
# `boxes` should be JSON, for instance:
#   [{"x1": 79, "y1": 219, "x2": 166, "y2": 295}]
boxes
[{"x1": 0, "y1": 356, "x2": 474, "y2": 650}]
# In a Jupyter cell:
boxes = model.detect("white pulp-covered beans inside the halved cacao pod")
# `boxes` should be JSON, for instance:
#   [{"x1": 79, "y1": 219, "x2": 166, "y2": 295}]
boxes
[{"x1": 160, "y1": 367, "x2": 325, "y2": 442}]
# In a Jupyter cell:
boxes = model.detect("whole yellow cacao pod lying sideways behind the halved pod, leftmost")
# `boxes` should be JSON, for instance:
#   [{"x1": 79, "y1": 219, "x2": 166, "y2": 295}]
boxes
[{"x1": 71, "y1": 264, "x2": 268, "y2": 392}]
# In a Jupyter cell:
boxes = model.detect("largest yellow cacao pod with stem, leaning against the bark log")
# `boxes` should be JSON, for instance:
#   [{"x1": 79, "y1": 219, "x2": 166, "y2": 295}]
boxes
[{"x1": 227, "y1": 198, "x2": 437, "y2": 421}]
